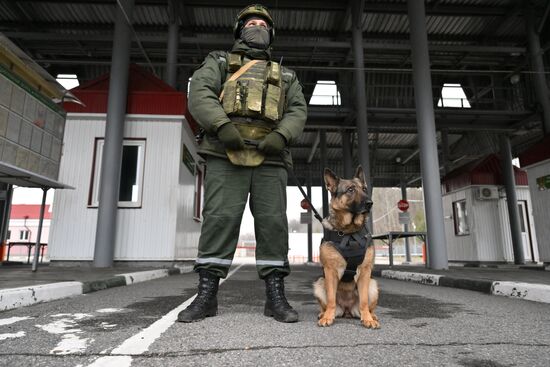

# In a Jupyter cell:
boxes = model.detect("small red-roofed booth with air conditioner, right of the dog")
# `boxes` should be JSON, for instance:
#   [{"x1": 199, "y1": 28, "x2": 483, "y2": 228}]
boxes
[{"x1": 442, "y1": 154, "x2": 540, "y2": 264}]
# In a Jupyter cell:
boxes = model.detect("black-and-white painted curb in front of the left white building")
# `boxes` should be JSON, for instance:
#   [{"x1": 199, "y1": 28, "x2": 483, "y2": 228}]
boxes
[{"x1": 0, "y1": 265, "x2": 192, "y2": 312}]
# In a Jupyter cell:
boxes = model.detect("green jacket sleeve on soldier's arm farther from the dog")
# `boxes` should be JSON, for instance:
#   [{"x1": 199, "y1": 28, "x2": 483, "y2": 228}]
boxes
[{"x1": 188, "y1": 51, "x2": 231, "y2": 135}]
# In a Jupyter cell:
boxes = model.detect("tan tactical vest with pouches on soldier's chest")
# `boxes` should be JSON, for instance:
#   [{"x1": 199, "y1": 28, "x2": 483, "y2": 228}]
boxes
[{"x1": 222, "y1": 53, "x2": 285, "y2": 123}]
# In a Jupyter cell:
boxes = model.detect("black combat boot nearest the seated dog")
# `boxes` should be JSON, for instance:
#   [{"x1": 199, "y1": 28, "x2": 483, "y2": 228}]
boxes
[{"x1": 264, "y1": 272, "x2": 298, "y2": 322}]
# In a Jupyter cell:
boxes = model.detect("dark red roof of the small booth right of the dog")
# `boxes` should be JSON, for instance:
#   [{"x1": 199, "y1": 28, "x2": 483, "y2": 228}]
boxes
[{"x1": 442, "y1": 154, "x2": 527, "y2": 192}]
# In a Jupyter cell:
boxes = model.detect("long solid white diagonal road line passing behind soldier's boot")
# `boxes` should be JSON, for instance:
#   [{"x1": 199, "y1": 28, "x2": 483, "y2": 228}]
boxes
[{"x1": 88, "y1": 264, "x2": 244, "y2": 367}]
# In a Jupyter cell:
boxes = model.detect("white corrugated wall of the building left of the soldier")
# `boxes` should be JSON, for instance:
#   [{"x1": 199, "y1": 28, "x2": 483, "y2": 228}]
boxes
[{"x1": 50, "y1": 115, "x2": 203, "y2": 261}]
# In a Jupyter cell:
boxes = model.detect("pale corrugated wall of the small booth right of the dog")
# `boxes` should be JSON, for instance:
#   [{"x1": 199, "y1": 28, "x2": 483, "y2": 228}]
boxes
[{"x1": 443, "y1": 186, "x2": 538, "y2": 262}]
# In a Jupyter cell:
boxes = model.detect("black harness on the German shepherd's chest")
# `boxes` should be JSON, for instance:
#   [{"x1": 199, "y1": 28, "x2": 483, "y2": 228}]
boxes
[{"x1": 323, "y1": 225, "x2": 373, "y2": 282}]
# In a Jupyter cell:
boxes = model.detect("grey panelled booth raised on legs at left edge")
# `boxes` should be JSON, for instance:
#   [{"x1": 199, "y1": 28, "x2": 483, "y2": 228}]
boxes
[{"x1": 0, "y1": 34, "x2": 74, "y2": 270}]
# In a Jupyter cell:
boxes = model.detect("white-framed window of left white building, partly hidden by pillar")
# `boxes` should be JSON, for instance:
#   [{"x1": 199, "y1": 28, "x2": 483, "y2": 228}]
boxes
[{"x1": 88, "y1": 138, "x2": 145, "y2": 208}]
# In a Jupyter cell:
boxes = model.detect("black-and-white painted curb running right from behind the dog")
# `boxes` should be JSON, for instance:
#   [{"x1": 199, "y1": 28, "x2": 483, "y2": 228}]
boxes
[{"x1": 372, "y1": 270, "x2": 550, "y2": 303}]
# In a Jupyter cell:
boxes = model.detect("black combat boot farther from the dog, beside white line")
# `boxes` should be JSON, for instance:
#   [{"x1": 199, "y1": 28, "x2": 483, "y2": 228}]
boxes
[{"x1": 178, "y1": 270, "x2": 220, "y2": 322}]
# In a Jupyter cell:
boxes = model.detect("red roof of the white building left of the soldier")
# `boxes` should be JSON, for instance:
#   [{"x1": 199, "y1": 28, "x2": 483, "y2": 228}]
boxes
[{"x1": 63, "y1": 64, "x2": 195, "y2": 133}]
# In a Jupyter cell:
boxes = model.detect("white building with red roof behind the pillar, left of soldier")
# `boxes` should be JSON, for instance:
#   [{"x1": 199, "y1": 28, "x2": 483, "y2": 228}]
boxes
[{"x1": 49, "y1": 65, "x2": 203, "y2": 262}]
